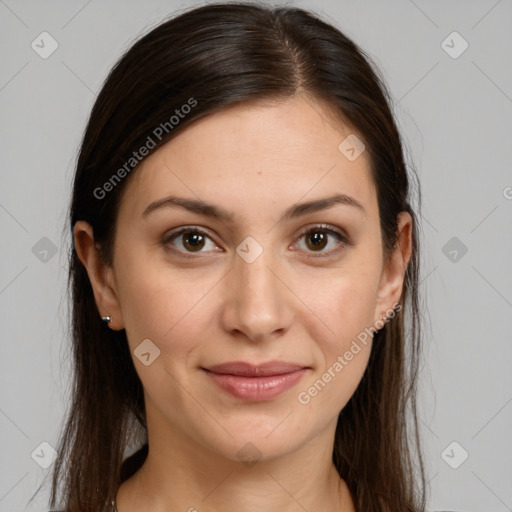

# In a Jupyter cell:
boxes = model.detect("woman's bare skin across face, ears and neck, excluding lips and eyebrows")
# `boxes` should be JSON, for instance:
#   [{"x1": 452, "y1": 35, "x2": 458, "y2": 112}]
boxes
[{"x1": 74, "y1": 94, "x2": 412, "y2": 512}]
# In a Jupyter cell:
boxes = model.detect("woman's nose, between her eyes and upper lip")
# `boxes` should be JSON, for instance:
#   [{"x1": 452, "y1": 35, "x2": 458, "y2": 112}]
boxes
[{"x1": 221, "y1": 243, "x2": 294, "y2": 343}]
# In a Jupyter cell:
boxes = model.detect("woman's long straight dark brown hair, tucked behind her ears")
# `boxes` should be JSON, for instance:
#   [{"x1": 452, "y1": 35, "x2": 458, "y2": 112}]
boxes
[{"x1": 37, "y1": 2, "x2": 425, "y2": 512}]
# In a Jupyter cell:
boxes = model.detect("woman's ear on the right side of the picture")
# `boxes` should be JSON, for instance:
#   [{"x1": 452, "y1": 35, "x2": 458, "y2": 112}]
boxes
[{"x1": 374, "y1": 211, "x2": 413, "y2": 325}]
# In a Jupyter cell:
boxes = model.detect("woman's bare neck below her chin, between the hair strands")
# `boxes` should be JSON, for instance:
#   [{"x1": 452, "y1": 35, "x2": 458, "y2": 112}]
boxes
[{"x1": 116, "y1": 414, "x2": 355, "y2": 512}]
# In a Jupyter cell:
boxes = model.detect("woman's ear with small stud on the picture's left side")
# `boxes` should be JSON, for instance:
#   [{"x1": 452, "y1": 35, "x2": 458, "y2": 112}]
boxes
[{"x1": 73, "y1": 220, "x2": 124, "y2": 330}]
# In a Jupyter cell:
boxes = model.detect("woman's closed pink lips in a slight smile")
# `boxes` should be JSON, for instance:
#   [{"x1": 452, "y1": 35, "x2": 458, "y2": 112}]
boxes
[{"x1": 202, "y1": 361, "x2": 308, "y2": 402}]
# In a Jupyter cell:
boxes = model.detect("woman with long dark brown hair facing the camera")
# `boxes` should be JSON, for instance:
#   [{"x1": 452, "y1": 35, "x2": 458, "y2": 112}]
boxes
[{"x1": 43, "y1": 3, "x2": 425, "y2": 512}]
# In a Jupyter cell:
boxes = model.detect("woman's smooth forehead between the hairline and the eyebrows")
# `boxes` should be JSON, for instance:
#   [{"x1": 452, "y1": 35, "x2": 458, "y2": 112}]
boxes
[{"x1": 121, "y1": 95, "x2": 377, "y2": 223}]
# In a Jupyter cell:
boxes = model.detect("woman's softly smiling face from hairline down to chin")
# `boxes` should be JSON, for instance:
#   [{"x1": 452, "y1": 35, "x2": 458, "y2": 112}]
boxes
[{"x1": 78, "y1": 92, "x2": 405, "y2": 460}]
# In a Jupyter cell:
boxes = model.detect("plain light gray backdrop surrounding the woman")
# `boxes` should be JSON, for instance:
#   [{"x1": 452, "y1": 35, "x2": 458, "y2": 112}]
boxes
[{"x1": 0, "y1": 0, "x2": 512, "y2": 512}]
